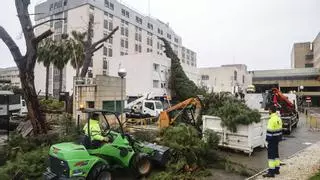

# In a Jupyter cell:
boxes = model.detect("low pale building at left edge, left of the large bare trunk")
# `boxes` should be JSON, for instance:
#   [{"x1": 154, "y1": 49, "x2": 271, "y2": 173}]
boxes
[{"x1": 0, "y1": 67, "x2": 21, "y2": 88}]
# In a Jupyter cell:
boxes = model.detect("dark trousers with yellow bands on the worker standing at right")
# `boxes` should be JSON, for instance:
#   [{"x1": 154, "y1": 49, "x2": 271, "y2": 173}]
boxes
[{"x1": 268, "y1": 140, "x2": 280, "y2": 174}]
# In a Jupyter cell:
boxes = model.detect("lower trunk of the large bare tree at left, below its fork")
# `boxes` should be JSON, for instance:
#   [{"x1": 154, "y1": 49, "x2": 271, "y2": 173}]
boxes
[{"x1": 19, "y1": 69, "x2": 47, "y2": 135}]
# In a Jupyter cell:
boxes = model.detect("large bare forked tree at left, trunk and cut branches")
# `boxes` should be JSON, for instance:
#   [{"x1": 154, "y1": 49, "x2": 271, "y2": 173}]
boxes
[{"x1": 0, "y1": 0, "x2": 65, "y2": 135}]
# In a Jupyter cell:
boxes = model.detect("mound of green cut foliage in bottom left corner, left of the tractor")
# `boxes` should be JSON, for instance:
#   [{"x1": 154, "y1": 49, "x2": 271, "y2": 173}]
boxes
[{"x1": 0, "y1": 114, "x2": 77, "y2": 180}]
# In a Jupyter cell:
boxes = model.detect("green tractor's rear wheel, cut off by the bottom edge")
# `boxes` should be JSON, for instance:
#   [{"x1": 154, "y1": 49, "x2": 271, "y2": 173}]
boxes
[{"x1": 87, "y1": 163, "x2": 111, "y2": 180}]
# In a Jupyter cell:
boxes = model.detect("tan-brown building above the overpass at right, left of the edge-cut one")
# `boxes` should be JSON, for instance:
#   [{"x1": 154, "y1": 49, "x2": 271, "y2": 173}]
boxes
[{"x1": 291, "y1": 42, "x2": 314, "y2": 68}]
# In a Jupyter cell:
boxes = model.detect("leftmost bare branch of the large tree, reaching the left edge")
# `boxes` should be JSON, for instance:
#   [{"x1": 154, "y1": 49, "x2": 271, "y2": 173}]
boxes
[{"x1": 0, "y1": 26, "x2": 22, "y2": 65}]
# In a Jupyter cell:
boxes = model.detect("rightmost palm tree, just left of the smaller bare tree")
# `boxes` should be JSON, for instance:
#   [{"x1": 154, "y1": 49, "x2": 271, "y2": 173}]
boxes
[{"x1": 70, "y1": 31, "x2": 87, "y2": 77}]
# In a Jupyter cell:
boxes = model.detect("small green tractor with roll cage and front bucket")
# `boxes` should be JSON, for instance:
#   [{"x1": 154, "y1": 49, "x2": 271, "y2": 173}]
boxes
[{"x1": 43, "y1": 109, "x2": 169, "y2": 180}]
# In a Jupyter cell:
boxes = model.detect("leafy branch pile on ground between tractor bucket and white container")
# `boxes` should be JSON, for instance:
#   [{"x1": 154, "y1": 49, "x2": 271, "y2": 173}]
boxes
[{"x1": 151, "y1": 124, "x2": 219, "y2": 180}]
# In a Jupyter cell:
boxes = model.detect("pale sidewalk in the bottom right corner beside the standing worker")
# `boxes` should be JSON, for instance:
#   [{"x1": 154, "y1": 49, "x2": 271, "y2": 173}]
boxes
[{"x1": 248, "y1": 141, "x2": 320, "y2": 180}]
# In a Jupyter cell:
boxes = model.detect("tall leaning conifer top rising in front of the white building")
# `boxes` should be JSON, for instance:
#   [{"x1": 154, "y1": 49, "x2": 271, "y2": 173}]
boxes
[{"x1": 160, "y1": 38, "x2": 199, "y2": 101}]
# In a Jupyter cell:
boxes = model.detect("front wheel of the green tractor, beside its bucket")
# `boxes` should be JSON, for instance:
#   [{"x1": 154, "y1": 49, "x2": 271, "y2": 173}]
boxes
[{"x1": 131, "y1": 154, "x2": 152, "y2": 177}]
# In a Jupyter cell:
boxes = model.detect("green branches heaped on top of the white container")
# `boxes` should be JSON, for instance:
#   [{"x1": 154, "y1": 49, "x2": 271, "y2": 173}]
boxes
[{"x1": 202, "y1": 93, "x2": 261, "y2": 132}]
